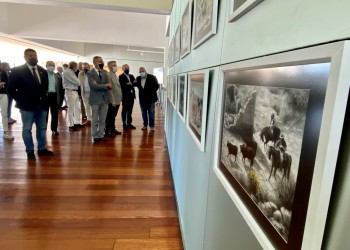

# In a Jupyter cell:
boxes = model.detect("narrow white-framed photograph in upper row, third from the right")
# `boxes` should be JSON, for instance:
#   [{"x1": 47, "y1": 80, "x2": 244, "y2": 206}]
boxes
[{"x1": 181, "y1": 0, "x2": 192, "y2": 58}]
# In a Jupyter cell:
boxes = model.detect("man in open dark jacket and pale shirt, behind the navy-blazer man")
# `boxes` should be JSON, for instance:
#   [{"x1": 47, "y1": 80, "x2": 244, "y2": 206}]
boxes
[{"x1": 46, "y1": 61, "x2": 60, "y2": 136}]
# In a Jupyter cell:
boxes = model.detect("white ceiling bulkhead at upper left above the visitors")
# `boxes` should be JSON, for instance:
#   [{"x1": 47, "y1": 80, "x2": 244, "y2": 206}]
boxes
[{"x1": 0, "y1": 0, "x2": 171, "y2": 55}]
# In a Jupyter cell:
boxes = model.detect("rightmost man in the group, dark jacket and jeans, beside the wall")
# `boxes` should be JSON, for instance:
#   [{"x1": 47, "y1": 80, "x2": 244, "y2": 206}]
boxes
[{"x1": 135, "y1": 67, "x2": 159, "y2": 130}]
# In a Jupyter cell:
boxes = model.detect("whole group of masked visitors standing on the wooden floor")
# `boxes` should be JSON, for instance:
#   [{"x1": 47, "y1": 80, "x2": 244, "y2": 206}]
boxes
[{"x1": 0, "y1": 49, "x2": 159, "y2": 160}]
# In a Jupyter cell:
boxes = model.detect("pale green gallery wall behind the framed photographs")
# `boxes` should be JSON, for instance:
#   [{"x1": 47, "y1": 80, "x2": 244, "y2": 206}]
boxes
[{"x1": 166, "y1": 0, "x2": 350, "y2": 250}]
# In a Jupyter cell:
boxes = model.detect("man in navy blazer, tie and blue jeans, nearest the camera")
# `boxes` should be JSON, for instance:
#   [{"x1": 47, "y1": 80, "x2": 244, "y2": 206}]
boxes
[{"x1": 7, "y1": 49, "x2": 53, "y2": 160}]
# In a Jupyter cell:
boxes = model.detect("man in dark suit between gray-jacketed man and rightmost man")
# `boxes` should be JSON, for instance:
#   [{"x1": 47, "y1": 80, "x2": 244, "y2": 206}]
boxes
[{"x1": 119, "y1": 64, "x2": 136, "y2": 130}]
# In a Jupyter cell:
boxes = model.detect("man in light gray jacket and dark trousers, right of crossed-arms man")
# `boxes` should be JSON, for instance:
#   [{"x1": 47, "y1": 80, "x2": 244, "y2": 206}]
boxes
[{"x1": 105, "y1": 61, "x2": 123, "y2": 137}]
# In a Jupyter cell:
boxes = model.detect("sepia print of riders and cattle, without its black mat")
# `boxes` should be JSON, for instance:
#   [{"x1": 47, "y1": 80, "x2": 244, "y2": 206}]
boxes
[{"x1": 220, "y1": 82, "x2": 310, "y2": 241}]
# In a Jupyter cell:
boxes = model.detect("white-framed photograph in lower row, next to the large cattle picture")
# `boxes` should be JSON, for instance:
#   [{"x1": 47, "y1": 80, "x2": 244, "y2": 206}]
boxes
[{"x1": 186, "y1": 70, "x2": 209, "y2": 151}]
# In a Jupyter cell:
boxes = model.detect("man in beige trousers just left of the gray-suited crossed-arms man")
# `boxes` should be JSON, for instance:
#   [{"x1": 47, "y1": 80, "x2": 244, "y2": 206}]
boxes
[{"x1": 78, "y1": 62, "x2": 91, "y2": 125}]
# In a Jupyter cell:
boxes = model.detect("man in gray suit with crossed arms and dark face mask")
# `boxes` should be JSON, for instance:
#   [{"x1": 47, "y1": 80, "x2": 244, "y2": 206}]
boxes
[{"x1": 88, "y1": 56, "x2": 112, "y2": 144}]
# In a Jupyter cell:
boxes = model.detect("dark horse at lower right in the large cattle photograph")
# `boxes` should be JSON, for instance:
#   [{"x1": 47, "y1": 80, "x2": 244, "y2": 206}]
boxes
[{"x1": 268, "y1": 146, "x2": 292, "y2": 181}]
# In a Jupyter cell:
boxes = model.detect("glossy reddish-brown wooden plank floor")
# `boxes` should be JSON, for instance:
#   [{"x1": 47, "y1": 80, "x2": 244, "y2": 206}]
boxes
[{"x1": 0, "y1": 103, "x2": 183, "y2": 250}]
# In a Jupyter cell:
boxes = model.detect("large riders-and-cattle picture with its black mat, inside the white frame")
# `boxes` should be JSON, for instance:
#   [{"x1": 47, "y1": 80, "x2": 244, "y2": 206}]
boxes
[{"x1": 218, "y1": 62, "x2": 330, "y2": 248}]
